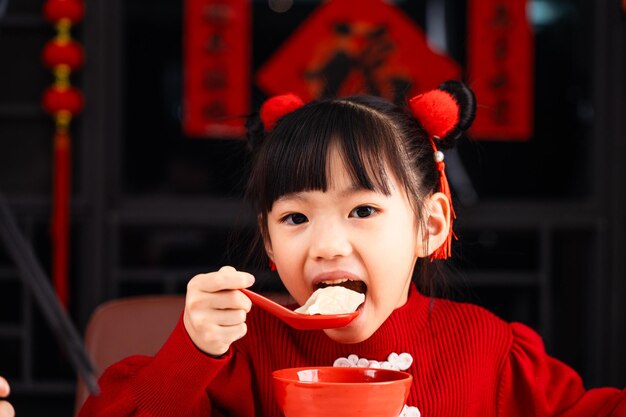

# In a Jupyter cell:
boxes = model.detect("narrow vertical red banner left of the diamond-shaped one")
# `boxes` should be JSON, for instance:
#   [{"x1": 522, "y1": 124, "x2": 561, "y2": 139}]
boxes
[{"x1": 183, "y1": 0, "x2": 252, "y2": 138}]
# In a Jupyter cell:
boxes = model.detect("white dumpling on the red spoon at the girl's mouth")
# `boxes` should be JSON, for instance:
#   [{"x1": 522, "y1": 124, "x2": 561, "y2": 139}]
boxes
[{"x1": 294, "y1": 286, "x2": 365, "y2": 315}]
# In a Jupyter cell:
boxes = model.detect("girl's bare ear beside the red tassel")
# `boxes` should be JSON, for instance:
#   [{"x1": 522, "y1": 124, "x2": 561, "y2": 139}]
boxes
[{"x1": 418, "y1": 193, "x2": 451, "y2": 257}]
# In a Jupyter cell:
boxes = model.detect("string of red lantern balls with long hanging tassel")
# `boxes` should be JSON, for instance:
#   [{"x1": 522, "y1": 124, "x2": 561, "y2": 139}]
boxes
[{"x1": 41, "y1": 0, "x2": 85, "y2": 308}]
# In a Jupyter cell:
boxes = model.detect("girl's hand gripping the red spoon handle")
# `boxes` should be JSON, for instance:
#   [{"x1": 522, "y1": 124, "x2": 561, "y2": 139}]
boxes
[{"x1": 183, "y1": 266, "x2": 254, "y2": 354}]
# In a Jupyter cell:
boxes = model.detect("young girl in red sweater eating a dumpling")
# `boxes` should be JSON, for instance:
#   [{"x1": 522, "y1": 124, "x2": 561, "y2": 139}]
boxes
[{"x1": 81, "y1": 82, "x2": 626, "y2": 417}]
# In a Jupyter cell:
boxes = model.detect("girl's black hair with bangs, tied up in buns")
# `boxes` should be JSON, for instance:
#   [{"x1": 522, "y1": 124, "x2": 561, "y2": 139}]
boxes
[{"x1": 246, "y1": 82, "x2": 475, "y2": 292}]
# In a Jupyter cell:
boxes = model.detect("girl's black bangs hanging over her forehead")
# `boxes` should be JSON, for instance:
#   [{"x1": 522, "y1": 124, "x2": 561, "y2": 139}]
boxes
[{"x1": 248, "y1": 100, "x2": 399, "y2": 213}]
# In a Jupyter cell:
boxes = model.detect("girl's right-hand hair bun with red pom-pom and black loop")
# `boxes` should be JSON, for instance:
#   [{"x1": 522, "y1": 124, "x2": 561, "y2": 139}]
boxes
[{"x1": 409, "y1": 81, "x2": 476, "y2": 148}]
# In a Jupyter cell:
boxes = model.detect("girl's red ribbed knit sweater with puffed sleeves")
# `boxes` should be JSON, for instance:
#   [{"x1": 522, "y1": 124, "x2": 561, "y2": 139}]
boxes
[{"x1": 80, "y1": 288, "x2": 626, "y2": 417}]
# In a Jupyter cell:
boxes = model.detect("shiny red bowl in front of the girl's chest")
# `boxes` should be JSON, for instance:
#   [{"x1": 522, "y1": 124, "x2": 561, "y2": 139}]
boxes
[{"x1": 272, "y1": 366, "x2": 413, "y2": 417}]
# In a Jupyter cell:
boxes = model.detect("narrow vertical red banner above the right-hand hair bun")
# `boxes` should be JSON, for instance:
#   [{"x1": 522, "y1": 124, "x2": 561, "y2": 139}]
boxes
[{"x1": 467, "y1": 0, "x2": 534, "y2": 141}]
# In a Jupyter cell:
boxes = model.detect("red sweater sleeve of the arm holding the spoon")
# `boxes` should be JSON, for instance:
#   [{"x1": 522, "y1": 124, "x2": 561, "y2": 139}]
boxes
[{"x1": 79, "y1": 318, "x2": 254, "y2": 417}]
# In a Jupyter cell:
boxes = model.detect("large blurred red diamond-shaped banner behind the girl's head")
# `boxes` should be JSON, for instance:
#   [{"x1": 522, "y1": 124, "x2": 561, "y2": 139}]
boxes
[{"x1": 255, "y1": 0, "x2": 461, "y2": 102}]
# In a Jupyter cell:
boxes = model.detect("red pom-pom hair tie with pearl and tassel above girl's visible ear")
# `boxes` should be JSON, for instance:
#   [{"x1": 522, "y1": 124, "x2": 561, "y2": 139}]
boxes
[{"x1": 409, "y1": 90, "x2": 460, "y2": 261}]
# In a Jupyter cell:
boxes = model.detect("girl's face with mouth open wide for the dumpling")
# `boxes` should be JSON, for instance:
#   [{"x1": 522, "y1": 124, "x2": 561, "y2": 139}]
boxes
[{"x1": 266, "y1": 151, "x2": 424, "y2": 343}]
